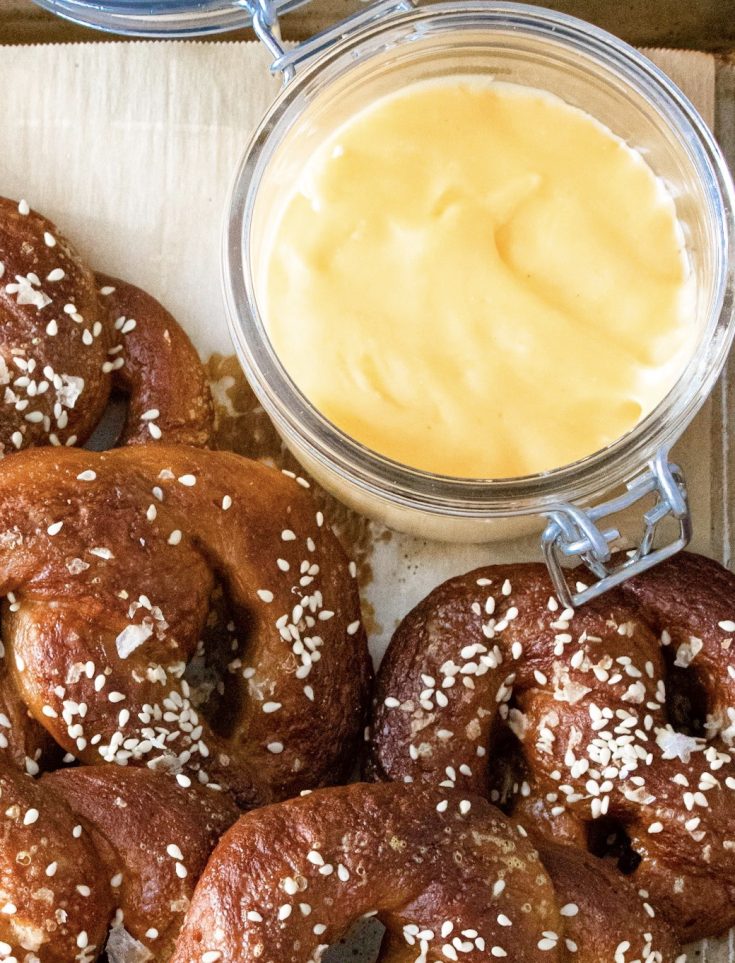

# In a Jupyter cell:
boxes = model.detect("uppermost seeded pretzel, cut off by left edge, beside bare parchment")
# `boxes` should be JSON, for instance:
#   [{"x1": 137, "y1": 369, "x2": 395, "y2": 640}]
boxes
[{"x1": 0, "y1": 198, "x2": 213, "y2": 455}]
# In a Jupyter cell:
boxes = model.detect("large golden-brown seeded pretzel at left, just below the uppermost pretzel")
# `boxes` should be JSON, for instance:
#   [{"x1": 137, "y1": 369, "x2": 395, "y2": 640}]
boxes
[{"x1": 0, "y1": 445, "x2": 370, "y2": 806}]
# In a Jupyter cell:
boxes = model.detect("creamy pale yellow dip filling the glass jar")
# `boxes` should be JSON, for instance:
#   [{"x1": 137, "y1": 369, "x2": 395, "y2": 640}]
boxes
[{"x1": 264, "y1": 78, "x2": 696, "y2": 478}]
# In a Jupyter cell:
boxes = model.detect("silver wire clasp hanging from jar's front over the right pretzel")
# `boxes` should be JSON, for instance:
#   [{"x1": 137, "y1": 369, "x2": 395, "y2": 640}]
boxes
[{"x1": 541, "y1": 450, "x2": 692, "y2": 608}]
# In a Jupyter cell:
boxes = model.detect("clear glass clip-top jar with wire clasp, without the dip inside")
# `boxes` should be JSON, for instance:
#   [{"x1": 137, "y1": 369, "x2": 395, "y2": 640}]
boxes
[{"x1": 38, "y1": 0, "x2": 735, "y2": 606}]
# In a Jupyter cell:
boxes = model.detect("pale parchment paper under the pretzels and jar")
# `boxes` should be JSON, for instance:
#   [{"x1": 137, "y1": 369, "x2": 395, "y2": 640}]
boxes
[{"x1": 0, "y1": 43, "x2": 735, "y2": 963}]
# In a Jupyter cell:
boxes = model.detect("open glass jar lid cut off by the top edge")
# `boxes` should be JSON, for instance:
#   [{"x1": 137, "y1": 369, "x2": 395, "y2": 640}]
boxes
[{"x1": 30, "y1": 0, "x2": 308, "y2": 38}]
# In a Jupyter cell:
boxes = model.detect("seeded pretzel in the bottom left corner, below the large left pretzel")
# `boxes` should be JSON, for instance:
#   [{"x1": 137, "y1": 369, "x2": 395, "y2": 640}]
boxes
[{"x1": 0, "y1": 764, "x2": 237, "y2": 963}]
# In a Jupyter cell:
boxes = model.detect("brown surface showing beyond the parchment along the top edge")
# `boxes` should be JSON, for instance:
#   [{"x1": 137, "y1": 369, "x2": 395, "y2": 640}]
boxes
[{"x1": 0, "y1": 0, "x2": 735, "y2": 51}]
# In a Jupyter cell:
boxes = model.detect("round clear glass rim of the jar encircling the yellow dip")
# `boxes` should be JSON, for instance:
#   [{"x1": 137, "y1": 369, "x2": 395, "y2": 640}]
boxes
[{"x1": 223, "y1": 0, "x2": 735, "y2": 518}]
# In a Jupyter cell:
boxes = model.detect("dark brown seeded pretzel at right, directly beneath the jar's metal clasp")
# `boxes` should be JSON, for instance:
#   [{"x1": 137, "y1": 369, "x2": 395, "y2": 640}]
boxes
[{"x1": 369, "y1": 554, "x2": 735, "y2": 944}]
